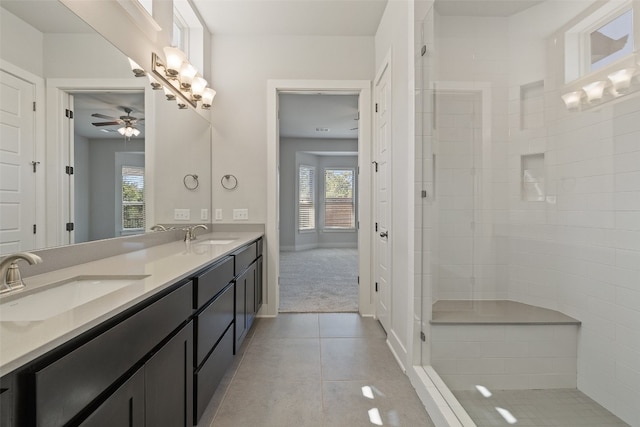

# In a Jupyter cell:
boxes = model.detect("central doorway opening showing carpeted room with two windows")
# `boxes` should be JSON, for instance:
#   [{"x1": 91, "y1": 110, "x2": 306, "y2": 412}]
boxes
[{"x1": 278, "y1": 92, "x2": 359, "y2": 312}]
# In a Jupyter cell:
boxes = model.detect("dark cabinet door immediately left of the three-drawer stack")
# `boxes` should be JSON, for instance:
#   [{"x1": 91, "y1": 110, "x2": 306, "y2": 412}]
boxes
[{"x1": 145, "y1": 323, "x2": 193, "y2": 427}]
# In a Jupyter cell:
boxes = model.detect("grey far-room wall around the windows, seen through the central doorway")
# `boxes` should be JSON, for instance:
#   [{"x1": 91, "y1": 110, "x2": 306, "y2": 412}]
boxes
[{"x1": 280, "y1": 138, "x2": 358, "y2": 250}]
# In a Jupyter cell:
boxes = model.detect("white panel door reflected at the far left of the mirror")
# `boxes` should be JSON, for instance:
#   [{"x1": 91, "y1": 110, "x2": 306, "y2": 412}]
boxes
[{"x1": 0, "y1": 70, "x2": 37, "y2": 255}]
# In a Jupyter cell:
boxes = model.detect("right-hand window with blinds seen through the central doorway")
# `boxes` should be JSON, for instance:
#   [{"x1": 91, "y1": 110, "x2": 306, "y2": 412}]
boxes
[{"x1": 324, "y1": 169, "x2": 356, "y2": 230}]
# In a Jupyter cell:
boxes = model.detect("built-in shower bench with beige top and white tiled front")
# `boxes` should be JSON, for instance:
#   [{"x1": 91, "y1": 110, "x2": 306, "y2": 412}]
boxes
[{"x1": 431, "y1": 300, "x2": 580, "y2": 390}]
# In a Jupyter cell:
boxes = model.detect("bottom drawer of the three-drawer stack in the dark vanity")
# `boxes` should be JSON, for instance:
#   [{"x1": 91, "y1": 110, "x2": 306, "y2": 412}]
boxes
[{"x1": 194, "y1": 327, "x2": 233, "y2": 423}]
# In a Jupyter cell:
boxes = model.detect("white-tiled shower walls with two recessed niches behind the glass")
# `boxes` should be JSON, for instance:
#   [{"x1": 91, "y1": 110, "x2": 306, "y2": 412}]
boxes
[{"x1": 414, "y1": 0, "x2": 640, "y2": 426}]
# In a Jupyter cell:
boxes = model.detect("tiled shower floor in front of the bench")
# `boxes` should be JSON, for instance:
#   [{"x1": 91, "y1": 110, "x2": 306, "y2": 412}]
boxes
[{"x1": 453, "y1": 389, "x2": 628, "y2": 427}]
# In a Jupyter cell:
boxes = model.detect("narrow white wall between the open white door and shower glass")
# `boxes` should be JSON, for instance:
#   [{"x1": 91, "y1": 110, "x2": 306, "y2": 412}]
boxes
[{"x1": 374, "y1": 0, "x2": 419, "y2": 367}]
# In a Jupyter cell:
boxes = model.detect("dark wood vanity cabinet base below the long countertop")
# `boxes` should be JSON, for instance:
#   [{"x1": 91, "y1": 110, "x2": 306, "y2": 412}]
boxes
[{"x1": 0, "y1": 239, "x2": 262, "y2": 427}]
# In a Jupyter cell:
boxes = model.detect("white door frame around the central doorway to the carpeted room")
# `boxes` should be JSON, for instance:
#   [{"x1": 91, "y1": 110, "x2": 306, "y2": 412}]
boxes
[{"x1": 266, "y1": 80, "x2": 374, "y2": 317}]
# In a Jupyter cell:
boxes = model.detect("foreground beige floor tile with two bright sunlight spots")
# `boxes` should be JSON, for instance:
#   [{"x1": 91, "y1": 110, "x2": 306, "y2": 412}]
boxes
[{"x1": 322, "y1": 380, "x2": 433, "y2": 427}]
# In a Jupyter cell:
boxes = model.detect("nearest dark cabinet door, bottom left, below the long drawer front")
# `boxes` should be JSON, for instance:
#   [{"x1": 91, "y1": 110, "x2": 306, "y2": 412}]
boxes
[{"x1": 80, "y1": 368, "x2": 145, "y2": 427}]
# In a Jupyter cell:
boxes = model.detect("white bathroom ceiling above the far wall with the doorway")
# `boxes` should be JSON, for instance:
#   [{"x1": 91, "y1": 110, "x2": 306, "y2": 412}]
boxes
[{"x1": 193, "y1": 0, "x2": 387, "y2": 36}]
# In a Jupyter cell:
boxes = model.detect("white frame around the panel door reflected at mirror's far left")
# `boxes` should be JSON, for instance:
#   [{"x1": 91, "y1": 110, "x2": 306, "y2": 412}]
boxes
[{"x1": 0, "y1": 59, "x2": 50, "y2": 249}]
